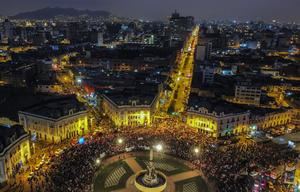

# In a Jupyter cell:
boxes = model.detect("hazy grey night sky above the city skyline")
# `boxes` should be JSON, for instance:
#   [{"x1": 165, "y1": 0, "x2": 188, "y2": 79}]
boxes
[{"x1": 0, "y1": 0, "x2": 300, "y2": 22}]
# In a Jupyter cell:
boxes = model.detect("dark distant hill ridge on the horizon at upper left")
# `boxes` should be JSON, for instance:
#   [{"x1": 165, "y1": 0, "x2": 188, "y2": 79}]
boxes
[{"x1": 11, "y1": 7, "x2": 110, "y2": 19}]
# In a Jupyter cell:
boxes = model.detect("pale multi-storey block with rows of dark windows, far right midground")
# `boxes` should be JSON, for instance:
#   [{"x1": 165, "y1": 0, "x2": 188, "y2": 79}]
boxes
[{"x1": 234, "y1": 82, "x2": 262, "y2": 105}]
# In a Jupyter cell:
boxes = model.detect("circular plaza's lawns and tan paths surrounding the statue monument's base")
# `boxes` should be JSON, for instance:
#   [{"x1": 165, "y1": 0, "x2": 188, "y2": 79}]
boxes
[{"x1": 93, "y1": 152, "x2": 212, "y2": 192}]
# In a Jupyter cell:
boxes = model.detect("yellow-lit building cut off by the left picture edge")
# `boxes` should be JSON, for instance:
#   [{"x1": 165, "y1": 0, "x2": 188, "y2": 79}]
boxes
[{"x1": 0, "y1": 125, "x2": 31, "y2": 184}]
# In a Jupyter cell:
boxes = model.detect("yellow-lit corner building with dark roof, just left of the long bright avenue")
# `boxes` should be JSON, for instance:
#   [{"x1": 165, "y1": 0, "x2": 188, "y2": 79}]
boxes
[{"x1": 102, "y1": 92, "x2": 158, "y2": 127}]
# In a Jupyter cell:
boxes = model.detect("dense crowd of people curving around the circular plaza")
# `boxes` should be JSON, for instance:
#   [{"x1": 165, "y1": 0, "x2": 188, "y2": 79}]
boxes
[{"x1": 27, "y1": 119, "x2": 296, "y2": 192}]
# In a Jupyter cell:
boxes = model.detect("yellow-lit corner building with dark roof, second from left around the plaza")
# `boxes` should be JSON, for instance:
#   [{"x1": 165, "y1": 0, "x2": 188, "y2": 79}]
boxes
[{"x1": 19, "y1": 96, "x2": 88, "y2": 143}]
